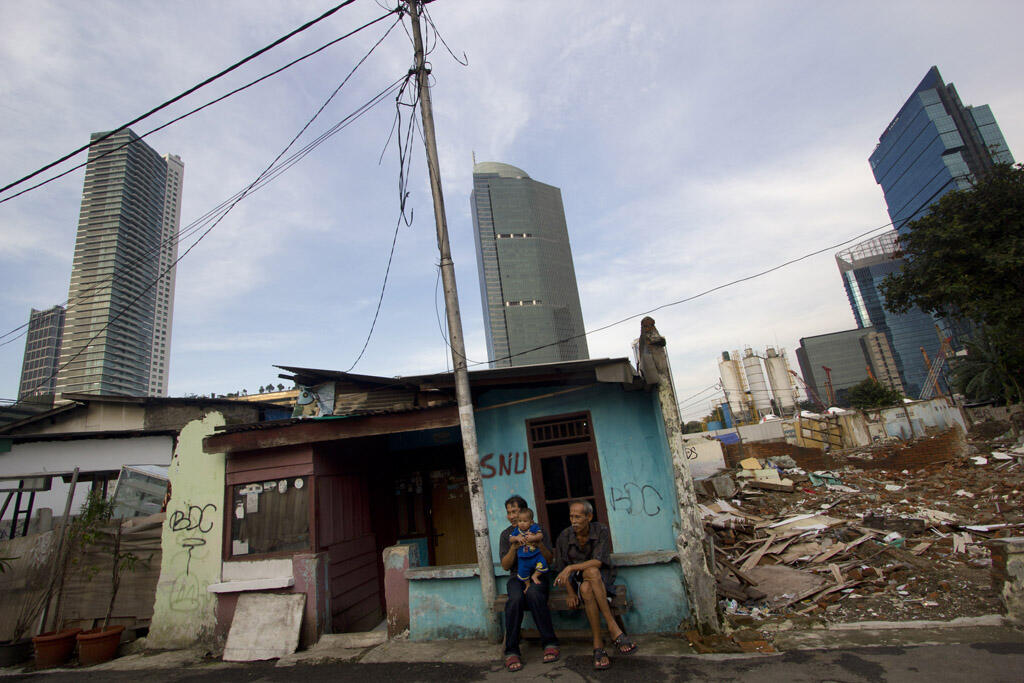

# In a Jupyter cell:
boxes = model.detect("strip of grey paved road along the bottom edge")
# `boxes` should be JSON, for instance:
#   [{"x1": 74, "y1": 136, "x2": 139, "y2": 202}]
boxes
[{"x1": 8, "y1": 642, "x2": 1024, "y2": 683}]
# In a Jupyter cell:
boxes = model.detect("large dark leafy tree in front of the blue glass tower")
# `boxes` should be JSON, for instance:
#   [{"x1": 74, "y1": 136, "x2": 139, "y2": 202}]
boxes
[{"x1": 881, "y1": 164, "x2": 1024, "y2": 401}]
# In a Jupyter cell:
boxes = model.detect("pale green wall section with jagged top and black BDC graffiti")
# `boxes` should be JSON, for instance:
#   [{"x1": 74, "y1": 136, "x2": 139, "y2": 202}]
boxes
[{"x1": 146, "y1": 413, "x2": 224, "y2": 649}]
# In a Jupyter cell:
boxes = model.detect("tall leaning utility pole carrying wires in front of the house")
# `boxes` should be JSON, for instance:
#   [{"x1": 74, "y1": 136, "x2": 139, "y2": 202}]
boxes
[{"x1": 408, "y1": 0, "x2": 498, "y2": 638}]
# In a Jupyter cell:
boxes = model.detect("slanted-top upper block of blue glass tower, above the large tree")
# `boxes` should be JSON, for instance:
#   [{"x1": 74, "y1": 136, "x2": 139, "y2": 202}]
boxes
[{"x1": 868, "y1": 67, "x2": 1014, "y2": 231}]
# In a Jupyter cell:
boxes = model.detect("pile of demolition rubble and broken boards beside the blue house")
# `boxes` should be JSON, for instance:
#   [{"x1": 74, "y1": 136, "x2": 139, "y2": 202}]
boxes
[{"x1": 697, "y1": 423, "x2": 1024, "y2": 624}]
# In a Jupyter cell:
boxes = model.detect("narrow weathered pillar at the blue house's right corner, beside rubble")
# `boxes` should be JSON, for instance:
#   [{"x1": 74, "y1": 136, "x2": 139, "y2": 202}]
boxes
[{"x1": 640, "y1": 317, "x2": 720, "y2": 633}]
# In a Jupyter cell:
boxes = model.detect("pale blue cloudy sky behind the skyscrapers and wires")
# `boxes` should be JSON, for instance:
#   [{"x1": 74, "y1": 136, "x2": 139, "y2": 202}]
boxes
[{"x1": 0, "y1": 0, "x2": 1024, "y2": 420}]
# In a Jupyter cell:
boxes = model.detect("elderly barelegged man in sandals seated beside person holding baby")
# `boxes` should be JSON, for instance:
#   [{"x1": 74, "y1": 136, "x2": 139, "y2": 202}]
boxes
[{"x1": 554, "y1": 501, "x2": 637, "y2": 669}]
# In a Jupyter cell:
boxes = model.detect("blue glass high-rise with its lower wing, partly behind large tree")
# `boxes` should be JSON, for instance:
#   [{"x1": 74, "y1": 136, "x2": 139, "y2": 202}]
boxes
[{"x1": 836, "y1": 67, "x2": 1014, "y2": 397}]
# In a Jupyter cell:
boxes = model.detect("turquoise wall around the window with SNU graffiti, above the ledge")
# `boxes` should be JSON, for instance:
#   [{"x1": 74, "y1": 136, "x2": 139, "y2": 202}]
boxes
[{"x1": 476, "y1": 384, "x2": 678, "y2": 562}]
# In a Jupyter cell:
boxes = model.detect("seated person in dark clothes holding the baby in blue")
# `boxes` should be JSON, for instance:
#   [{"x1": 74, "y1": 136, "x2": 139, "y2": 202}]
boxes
[{"x1": 498, "y1": 496, "x2": 559, "y2": 671}]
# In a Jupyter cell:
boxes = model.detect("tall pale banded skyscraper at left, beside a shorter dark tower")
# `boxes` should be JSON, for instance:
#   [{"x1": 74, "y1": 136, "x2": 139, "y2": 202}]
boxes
[{"x1": 56, "y1": 129, "x2": 184, "y2": 396}]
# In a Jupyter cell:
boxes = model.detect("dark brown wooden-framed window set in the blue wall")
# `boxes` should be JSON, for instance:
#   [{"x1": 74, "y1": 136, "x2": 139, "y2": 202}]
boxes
[{"x1": 526, "y1": 413, "x2": 608, "y2": 544}]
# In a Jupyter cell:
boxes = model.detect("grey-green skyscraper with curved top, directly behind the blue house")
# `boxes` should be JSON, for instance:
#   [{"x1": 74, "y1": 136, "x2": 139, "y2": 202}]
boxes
[{"x1": 470, "y1": 162, "x2": 589, "y2": 368}]
